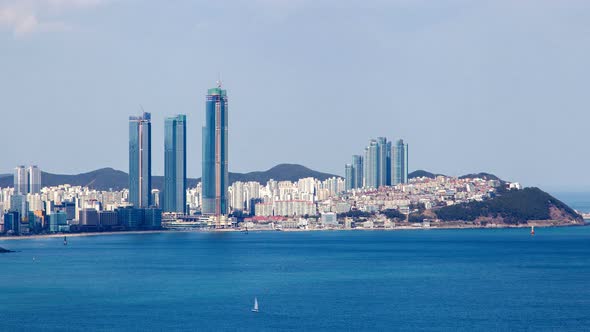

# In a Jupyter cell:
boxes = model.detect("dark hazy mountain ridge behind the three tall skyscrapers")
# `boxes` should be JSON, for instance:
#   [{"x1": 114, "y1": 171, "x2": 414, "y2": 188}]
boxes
[{"x1": 0, "y1": 164, "x2": 338, "y2": 190}]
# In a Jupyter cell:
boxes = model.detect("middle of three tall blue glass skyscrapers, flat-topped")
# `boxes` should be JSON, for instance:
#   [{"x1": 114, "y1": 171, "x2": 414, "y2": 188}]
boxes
[{"x1": 163, "y1": 114, "x2": 186, "y2": 213}]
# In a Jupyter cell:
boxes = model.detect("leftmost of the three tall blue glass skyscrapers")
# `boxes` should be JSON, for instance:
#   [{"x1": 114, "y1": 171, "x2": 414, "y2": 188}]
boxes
[{"x1": 129, "y1": 112, "x2": 152, "y2": 208}]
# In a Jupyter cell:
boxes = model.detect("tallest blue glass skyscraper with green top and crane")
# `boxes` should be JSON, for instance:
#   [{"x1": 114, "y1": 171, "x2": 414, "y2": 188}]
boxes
[{"x1": 202, "y1": 82, "x2": 229, "y2": 216}]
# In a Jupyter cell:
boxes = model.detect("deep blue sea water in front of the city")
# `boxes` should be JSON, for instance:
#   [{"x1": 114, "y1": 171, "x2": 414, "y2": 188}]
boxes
[{"x1": 0, "y1": 227, "x2": 590, "y2": 331}]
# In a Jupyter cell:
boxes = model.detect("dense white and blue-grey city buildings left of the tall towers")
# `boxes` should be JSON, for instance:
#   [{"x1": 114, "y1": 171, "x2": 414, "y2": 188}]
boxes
[{"x1": 0, "y1": 183, "x2": 162, "y2": 235}]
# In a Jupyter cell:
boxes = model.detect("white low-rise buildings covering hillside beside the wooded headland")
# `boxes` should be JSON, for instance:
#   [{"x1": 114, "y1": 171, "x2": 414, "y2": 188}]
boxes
[{"x1": 243, "y1": 176, "x2": 504, "y2": 230}]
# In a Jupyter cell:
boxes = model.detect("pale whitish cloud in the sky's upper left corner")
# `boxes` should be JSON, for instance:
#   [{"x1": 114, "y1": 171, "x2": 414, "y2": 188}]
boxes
[{"x1": 0, "y1": 0, "x2": 105, "y2": 38}]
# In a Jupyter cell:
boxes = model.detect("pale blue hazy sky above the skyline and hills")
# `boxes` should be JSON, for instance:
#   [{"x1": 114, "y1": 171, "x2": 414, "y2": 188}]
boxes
[{"x1": 0, "y1": 0, "x2": 590, "y2": 190}]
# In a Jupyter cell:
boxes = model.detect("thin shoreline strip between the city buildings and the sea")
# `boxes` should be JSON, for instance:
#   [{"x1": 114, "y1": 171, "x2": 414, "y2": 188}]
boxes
[{"x1": 0, "y1": 223, "x2": 590, "y2": 242}]
